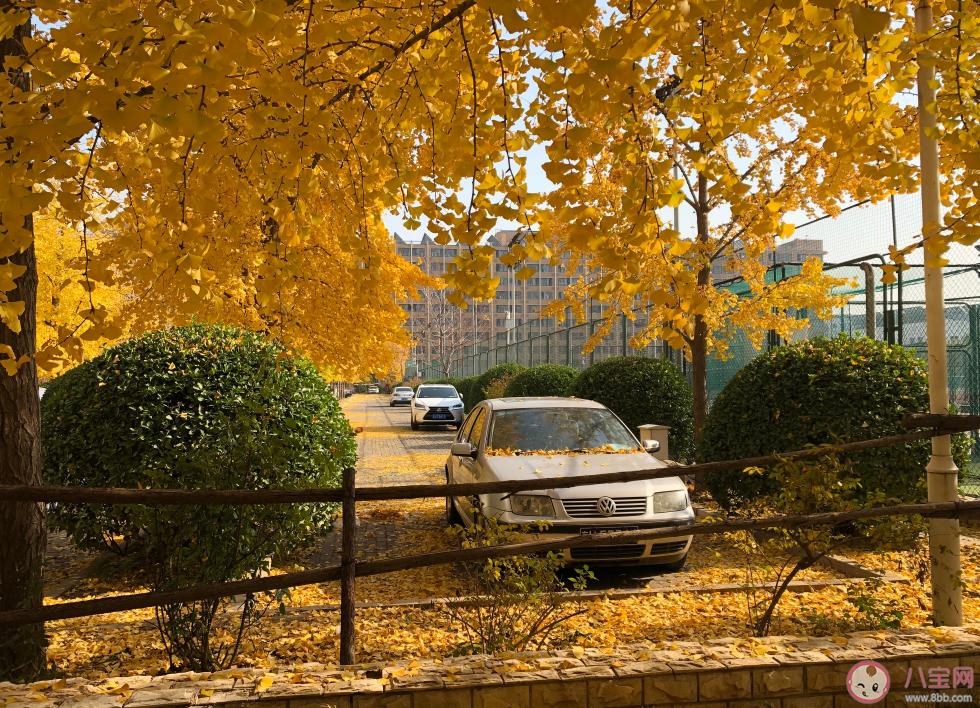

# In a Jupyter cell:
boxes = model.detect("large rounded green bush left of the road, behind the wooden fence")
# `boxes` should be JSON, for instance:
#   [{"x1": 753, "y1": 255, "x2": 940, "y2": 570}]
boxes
[{"x1": 41, "y1": 325, "x2": 357, "y2": 670}]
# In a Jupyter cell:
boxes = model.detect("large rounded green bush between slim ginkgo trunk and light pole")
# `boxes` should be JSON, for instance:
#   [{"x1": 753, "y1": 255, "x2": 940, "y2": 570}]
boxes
[{"x1": 698, "y1": 335, "x2": 968, "y2": 509}]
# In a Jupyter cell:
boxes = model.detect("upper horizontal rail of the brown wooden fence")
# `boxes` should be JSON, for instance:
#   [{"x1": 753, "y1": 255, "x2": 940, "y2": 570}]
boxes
[{"x1": 0, "y1": 424, "x2": 968, "y2": 506}]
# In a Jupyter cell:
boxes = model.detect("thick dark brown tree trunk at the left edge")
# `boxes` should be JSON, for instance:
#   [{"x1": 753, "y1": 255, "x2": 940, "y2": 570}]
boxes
[{"x1": 0, "y1": 0, "x2": 47, "y2": 680}]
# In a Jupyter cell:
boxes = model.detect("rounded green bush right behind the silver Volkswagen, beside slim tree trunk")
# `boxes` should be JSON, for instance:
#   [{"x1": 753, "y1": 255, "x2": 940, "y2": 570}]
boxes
[{"x1": 568, "y1": 356, "x2": 694, "y2": 460}]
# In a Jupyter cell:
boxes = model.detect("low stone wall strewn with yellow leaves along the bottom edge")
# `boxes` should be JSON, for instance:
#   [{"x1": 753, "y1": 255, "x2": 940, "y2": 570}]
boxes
[{"x1": 0, "y1": 628, "x2": 980, "y2": 708}]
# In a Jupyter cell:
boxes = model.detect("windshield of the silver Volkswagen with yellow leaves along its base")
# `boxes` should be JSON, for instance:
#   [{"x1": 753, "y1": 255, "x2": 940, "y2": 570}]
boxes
[{"x1": 488, "y1": 408, "x2": 639, "y2": 451}]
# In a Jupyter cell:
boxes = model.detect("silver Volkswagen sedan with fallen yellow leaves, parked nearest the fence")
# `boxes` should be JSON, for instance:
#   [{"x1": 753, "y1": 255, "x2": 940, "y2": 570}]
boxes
[{"x1": 446, "y1": 398, "x2": 694, "y2": 572}]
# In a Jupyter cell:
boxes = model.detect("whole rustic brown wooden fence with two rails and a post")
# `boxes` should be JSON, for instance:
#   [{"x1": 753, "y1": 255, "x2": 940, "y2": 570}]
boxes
[{"x1": 0, "y1": 414, "x2": 980, "y2": 665}]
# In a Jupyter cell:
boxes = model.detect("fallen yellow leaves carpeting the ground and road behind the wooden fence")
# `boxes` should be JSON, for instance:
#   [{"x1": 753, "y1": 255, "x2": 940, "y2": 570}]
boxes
[{"x1": 38, "y1": 399, "x2": 980, "y2": 678}]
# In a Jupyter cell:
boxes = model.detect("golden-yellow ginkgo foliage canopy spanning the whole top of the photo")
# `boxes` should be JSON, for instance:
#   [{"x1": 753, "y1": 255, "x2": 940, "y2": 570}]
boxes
[{"x1": 0, "y1": 0, "x2": 980, "y2": 382}]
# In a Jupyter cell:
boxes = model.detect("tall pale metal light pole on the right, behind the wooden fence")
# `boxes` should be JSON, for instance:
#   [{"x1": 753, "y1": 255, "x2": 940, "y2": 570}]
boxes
[{"x1": 915, "y1": 0, "x2": 963, "y2": 626}]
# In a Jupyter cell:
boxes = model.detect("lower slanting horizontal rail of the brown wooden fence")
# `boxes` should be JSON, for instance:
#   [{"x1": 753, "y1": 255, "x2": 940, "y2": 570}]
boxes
[{"x1": 0, "y1": 501, "x2": 980, "y2": 627}]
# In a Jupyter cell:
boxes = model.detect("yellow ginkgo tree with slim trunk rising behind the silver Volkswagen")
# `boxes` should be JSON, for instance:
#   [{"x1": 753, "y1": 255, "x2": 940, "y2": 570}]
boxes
[{"x1": 537, "y1": 3, "x2": 917, "y2": 432}]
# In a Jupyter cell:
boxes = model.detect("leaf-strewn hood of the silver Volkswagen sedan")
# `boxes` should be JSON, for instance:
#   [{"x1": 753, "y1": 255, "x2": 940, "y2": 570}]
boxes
[{"x1": 481, "y1": 452, "x2": 684, "y2": 499}]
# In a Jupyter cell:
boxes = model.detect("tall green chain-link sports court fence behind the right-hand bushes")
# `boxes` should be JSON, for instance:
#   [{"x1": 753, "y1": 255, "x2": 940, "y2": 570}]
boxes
[{"x1": 419, "y1": 195, "x2": 980, "y2": 496}]
